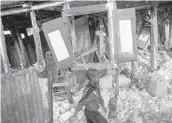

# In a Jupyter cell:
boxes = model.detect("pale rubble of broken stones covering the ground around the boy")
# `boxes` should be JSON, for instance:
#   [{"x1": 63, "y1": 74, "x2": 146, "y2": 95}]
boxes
[{"x1": 54, "y1": 51, "x2": 172, "y2": 123}]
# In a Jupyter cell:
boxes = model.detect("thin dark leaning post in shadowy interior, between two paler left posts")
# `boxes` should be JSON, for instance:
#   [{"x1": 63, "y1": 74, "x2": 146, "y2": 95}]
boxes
[{"x1": 15, "y1": 26, "x2": 26, "y2": 69}]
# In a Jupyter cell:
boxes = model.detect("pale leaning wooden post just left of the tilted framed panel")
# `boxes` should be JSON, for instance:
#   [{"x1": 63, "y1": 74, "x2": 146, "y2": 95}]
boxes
[{"x1": 30, "y1": 11, "x2": 45, "y2": 70}]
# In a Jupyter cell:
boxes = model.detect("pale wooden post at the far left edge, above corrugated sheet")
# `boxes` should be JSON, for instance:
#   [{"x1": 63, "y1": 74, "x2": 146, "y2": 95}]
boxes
[{"x1": 0, "y1": 20, "x2": 10, "y2": 73}]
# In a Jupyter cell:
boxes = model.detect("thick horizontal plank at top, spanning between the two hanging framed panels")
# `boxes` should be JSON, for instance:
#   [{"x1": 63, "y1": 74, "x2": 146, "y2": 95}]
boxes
[{"x1": 63, "y1": 4, "x2": 108, "y2": 16}]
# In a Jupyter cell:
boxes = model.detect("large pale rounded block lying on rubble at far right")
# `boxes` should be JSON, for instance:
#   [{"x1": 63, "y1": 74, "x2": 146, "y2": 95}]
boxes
[{"x1": 148, "y1": 75, "x2": 166, "y2": 97}]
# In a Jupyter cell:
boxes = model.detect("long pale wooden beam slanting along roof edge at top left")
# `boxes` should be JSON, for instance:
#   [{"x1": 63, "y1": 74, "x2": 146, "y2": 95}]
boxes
[{"x1": 0, "y1": 2, "x2": 65, "y2": 16}]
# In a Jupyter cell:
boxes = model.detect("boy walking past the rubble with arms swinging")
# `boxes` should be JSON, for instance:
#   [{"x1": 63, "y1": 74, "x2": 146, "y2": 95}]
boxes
[{"x1": 69, "y1": 69, "x2": 108, "y2": 123}]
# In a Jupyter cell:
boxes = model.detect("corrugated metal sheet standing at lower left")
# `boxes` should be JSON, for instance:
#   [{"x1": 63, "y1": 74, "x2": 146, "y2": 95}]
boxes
[{"x1": 1, "y1": 68, "x2": 50, "y2": 123}]
